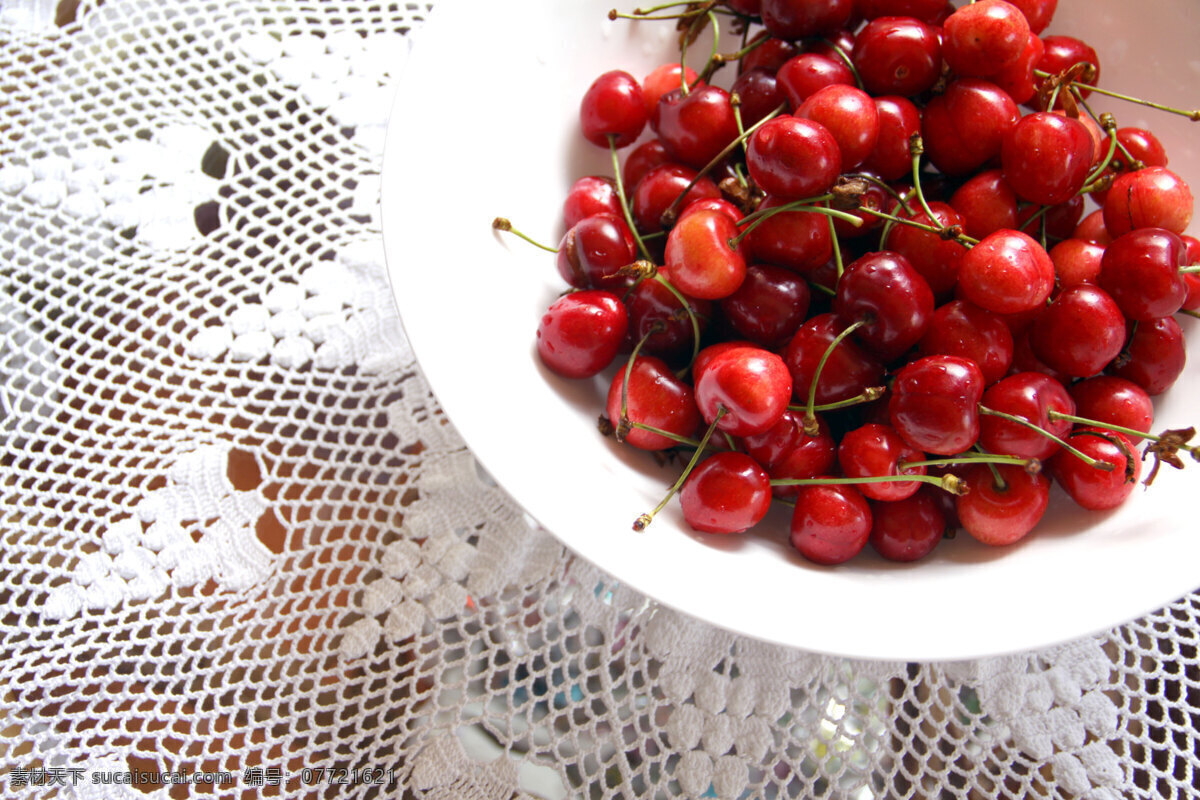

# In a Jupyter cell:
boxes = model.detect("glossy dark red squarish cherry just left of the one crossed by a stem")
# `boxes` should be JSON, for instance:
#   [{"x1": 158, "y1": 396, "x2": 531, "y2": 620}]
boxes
[{"x1": 888, "y1": 355, "x2": 985, "y2": 456}]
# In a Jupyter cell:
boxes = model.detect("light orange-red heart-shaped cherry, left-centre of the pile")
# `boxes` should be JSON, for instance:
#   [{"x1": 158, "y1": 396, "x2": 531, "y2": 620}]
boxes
[{"x1": 666, "y1": 210, "x2": 746, "y2": 300}]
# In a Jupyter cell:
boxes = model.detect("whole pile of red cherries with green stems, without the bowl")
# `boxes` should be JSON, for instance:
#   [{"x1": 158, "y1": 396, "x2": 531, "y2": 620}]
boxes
[{"x1": 516, "y1": 0, "x2": 1200, "y2": 564}]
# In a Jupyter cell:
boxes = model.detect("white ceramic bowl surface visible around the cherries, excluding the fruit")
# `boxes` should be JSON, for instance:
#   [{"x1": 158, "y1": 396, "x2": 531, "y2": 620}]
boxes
[{"x1": 383, "y1": 0, "x2": 1200, "y2": 660}]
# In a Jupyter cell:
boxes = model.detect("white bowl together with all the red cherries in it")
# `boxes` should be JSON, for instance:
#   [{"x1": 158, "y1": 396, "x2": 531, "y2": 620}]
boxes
[{"x1": 383, "y1": 0, "x2": 1200, "y2": 660}]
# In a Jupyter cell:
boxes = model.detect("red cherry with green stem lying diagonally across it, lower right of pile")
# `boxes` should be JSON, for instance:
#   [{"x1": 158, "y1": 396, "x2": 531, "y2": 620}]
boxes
[{"x1": 979, "y1": 372, "x2": 1075, "y2": 461}]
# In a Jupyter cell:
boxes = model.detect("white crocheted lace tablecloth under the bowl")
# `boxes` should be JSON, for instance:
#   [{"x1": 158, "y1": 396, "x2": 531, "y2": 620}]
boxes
[{"x1": 0, "y1": 0, "x2": 1200, "y2": 800}]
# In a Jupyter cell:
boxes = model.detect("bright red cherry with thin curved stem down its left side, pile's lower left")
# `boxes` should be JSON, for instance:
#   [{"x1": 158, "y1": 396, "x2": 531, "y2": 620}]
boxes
[{"x1": 605, "y1": 355, "x2": 701, "y2": 450}]
